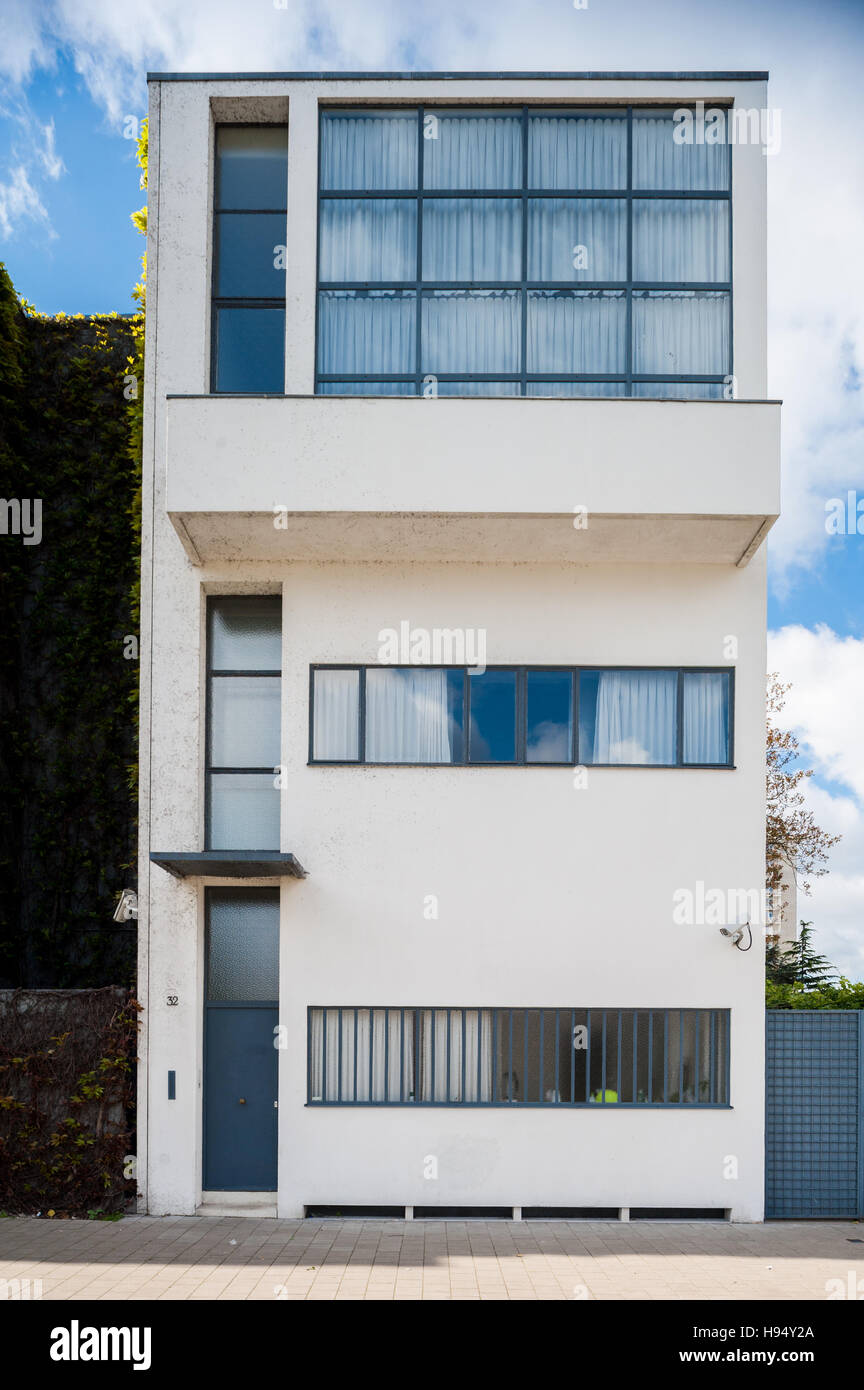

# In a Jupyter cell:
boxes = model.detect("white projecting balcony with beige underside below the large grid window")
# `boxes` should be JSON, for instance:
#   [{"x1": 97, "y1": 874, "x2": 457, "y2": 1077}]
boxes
[{"x1": 165, "y1": 396, "x2": 779, "y2": 564}]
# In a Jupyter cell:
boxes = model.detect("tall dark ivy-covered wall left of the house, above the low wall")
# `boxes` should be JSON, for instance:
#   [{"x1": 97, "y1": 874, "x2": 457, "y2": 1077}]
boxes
[{"x1": 0, "y1": 263, "x2": 143, "y2": 988}]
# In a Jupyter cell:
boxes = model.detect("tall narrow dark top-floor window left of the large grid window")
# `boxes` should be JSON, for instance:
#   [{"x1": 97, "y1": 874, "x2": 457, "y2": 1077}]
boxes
[{"x1": 213, "y1": 125, "x2": 288, "y2": 395}]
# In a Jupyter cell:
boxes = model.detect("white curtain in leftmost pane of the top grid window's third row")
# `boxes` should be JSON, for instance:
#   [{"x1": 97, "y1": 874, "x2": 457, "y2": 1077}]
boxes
[{"x1": 318, "y1": 289, "x2": 417, "y2": 375}]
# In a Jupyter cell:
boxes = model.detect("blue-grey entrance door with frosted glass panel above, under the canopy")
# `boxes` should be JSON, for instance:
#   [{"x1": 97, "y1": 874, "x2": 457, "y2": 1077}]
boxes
[{"x1": 203, "y1": 888, "x2": 279, "y2": 1193}]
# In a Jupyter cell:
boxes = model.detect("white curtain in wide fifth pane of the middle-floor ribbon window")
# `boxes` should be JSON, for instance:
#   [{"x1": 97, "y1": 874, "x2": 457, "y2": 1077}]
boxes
[{"x1": 592, "y1": 671, "x2": 678, "y2": 763}]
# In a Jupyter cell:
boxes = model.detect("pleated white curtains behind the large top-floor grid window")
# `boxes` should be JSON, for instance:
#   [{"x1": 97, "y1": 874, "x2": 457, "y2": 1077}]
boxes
[{"x1": 318, "y1": 111, "x2": 731, "y2": 395}]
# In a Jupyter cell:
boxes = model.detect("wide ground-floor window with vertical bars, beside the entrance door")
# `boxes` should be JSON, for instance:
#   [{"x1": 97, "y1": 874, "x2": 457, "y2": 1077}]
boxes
[{"x1": 307, "y1": 1006, "x2": 729, "y2": 1108}]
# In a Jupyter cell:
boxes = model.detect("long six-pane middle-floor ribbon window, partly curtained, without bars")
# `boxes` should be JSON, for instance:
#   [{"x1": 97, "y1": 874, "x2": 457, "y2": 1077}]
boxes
[{"x1": 310, "y1": 666, "x2": 733, "y2": 767}]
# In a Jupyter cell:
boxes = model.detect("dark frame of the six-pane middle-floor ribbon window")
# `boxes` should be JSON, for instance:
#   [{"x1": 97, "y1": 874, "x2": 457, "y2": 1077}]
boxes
[{"x1": 307, "y1": 662, "x2": 736, "y2": 771}]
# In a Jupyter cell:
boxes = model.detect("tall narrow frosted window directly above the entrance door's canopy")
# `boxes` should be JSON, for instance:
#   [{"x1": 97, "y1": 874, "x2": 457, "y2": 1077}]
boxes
[{"x1": 207, "y1": 598, "x2": 282, "y2": 849}]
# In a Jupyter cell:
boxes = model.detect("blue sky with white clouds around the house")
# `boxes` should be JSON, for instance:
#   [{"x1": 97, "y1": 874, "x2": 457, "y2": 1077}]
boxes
[{"x1": 0, "y1": 0, "x2": 864, "y2": 977}]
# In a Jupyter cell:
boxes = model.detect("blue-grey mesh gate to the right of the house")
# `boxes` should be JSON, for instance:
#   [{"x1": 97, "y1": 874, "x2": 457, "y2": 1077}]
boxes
[{"x1": 765, "y1": 1009, "x2": 864, "y2": 1220}]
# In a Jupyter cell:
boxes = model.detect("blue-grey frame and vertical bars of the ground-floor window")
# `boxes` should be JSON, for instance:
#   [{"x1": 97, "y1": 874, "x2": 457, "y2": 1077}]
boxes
[{"x1": 304, "y1": 1004, "x2": 733, "y2": 1112}]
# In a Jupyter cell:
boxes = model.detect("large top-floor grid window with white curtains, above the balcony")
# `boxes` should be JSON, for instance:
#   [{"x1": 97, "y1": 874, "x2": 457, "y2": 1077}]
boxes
[{"x1": 317, "y1": 107, "x2": 732, "y2": 399}]
